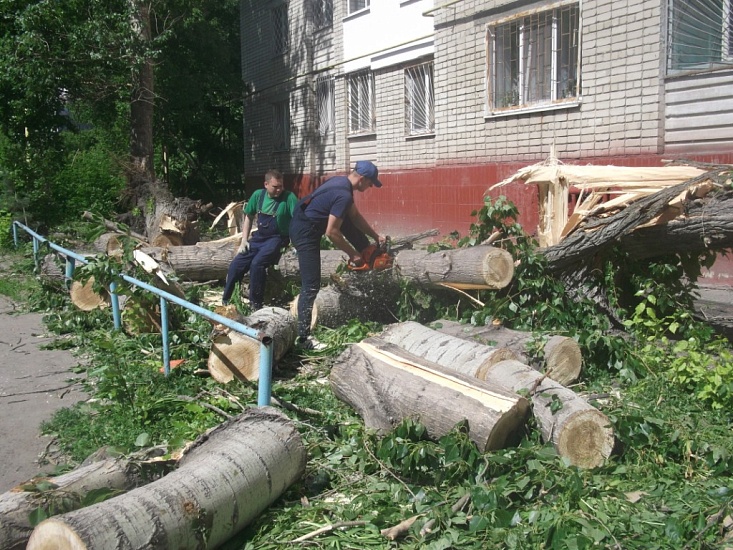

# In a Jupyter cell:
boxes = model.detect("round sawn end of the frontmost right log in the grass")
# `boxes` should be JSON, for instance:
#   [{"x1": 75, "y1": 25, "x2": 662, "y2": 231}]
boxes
[{"x1": 556, "y1": 409, "x2": 614, "y2": 468}]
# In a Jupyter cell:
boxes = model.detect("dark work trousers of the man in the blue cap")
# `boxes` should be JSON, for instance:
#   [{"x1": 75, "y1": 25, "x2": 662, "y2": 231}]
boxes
[{"x1": 290, "y1": 209, "x2": 369, "y2": 338}]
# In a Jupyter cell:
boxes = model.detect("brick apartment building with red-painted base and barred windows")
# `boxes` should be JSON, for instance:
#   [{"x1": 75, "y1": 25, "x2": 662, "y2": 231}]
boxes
[{"x1": 241, "y1": 0, "x2": 733, "y2": 248}]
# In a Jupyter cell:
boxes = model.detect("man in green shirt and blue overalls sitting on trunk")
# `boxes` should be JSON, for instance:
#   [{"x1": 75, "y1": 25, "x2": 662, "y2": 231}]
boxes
[{"x1": 221, "y1": 170, "x2": 298, "y2": 311}]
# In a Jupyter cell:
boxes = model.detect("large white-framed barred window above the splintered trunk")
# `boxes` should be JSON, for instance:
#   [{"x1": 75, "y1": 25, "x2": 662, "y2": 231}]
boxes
[{"x1": 487, "y1": 4, "x2": 580, "y2": 111}]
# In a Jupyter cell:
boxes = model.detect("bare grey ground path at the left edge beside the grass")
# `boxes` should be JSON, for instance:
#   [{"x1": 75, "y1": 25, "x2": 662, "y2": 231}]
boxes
[{"x1": 0, "y1": 298, "x2": 86, "y2": 493}]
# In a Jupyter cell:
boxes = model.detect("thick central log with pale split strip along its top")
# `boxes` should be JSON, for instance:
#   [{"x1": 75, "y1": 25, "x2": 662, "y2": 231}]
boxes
[{"x1": 330, "y1": 338, "x2": 529, "y2": 452}]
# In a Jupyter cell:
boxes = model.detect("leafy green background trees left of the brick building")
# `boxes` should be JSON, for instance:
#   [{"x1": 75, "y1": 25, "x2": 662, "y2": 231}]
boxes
[{"x1": 0, "y1": 0, "x2": 242, "y2": 231}]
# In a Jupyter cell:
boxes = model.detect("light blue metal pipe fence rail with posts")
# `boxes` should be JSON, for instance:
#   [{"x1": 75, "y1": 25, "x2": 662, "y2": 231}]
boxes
[{"x1": 13, "y1": 221, "x2": 273, "y2": 407}]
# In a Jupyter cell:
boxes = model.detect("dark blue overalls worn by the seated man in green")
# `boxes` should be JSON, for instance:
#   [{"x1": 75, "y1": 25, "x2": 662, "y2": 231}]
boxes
[{"x1": 222, "y1": 212, "x2": 288, "y2": 309}]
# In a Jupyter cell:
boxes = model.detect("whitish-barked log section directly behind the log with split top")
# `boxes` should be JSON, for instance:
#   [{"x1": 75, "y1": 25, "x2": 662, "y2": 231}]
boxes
[{"x1": 379, "y1": 321, "x2": 517, "y2": 380}]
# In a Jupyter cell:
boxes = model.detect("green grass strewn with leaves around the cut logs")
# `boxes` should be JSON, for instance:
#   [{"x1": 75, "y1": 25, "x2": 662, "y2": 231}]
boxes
[{"x1": 0, "y1": 247, "x2": 733, "y2": 550}]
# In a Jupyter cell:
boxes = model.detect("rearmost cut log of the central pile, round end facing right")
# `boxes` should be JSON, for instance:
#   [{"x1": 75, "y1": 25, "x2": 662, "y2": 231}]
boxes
[{"x1": 431, "y1": 319, "x2": 583, "y2": 386}]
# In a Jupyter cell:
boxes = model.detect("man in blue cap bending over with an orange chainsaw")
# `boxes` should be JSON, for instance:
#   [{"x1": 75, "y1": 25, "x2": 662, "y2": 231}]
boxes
[{"x1": 290, "y1": 160, "x2": 385, "y2": 349}]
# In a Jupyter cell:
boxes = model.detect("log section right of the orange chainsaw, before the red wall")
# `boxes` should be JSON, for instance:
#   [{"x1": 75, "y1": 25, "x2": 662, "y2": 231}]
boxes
[{"x1": 395, "y1": 246, "x2": 514, "y2": 290}]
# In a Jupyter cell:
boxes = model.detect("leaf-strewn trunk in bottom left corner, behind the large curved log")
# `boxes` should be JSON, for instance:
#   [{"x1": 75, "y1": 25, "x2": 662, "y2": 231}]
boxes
[{"x1": 0, "y1": 452, "x2": 172, "y2": 550}]
